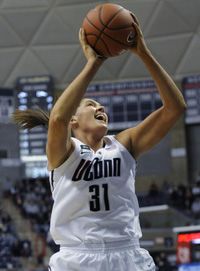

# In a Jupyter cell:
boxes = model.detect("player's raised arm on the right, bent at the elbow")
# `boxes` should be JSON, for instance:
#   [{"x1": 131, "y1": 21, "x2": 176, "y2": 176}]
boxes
[{"x1": 116, "y1": 16, "x2": 186, "y2": 158}]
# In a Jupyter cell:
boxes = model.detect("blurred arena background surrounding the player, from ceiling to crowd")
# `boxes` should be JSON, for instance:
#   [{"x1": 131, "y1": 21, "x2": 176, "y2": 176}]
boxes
[{"x1": 0, "y1": 0, "x2": 200, "y2": 271}]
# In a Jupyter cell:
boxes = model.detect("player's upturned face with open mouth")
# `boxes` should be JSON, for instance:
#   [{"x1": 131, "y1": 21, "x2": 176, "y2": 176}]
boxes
[{"x1": 76, "y1": 99, "x2": 108, "y2": 133}]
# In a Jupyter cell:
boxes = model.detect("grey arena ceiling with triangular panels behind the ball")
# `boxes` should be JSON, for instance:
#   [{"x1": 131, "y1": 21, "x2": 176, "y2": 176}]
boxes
[{"x1": 0, "y1": 0, "x2": 200, "y2": 88}]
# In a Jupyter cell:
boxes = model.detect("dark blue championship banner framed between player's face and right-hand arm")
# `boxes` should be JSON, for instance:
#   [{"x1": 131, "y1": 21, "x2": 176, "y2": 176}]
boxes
[{"x1": 86, "y1": 80, "x2": 162, "y2": 130}]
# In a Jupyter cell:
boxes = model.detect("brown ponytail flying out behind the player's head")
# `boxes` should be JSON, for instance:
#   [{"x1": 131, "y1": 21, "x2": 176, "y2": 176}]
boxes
[{"x1": 12, "y1": 108, "x2": 50, "y2": 129}]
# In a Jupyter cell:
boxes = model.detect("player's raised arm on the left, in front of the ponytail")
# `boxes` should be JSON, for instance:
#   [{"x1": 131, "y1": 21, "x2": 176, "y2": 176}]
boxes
[{"x1": 46, "y1": 29, "x2": 103, "y2": 169}]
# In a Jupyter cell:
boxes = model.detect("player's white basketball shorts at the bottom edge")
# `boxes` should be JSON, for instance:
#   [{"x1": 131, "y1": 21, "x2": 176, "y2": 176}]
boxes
[{"x1": 49, "y1": 240, "x2": 155, "y2": 271}]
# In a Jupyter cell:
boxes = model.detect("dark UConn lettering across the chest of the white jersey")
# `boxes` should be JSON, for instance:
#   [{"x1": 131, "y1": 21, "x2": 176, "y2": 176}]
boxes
[{"x1": 72, "y1": 158, "x2": 121, "y2": 182}]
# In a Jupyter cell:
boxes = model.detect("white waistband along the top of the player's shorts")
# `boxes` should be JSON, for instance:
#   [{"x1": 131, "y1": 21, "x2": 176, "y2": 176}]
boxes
[{"x1": 60, "y1": 239, "x2": 140, "y2": 252}]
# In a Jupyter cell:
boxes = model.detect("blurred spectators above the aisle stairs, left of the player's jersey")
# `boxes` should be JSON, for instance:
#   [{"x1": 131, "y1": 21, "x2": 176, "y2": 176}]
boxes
[{"x1": 10, "y1": 178, "x2": 53, "y2": 237}]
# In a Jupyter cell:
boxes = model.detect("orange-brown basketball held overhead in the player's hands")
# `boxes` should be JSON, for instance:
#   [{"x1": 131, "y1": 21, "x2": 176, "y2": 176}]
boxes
[{"x1": 82, "y1": 3, "x2": 136, "y2": 57}]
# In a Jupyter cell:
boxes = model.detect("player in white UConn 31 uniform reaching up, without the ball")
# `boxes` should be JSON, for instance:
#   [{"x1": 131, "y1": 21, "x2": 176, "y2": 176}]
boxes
[{"x1": 14, "y1": 15, "x2": 186, "y2": 271}]
